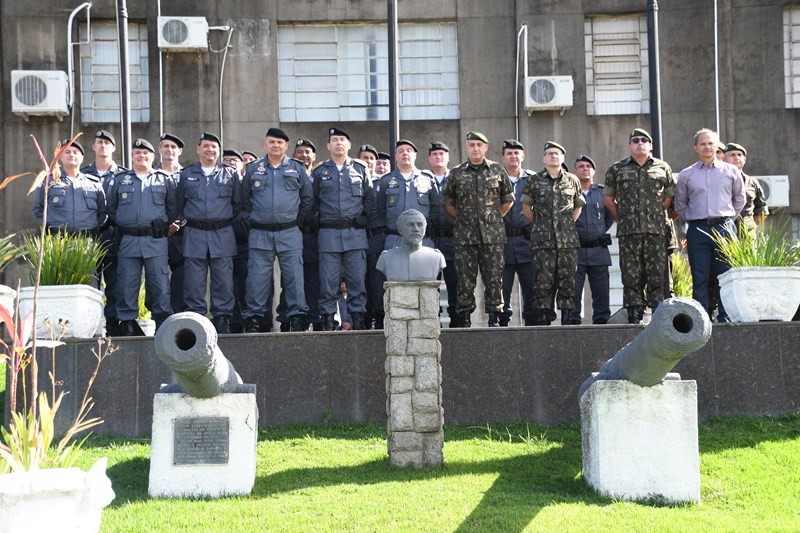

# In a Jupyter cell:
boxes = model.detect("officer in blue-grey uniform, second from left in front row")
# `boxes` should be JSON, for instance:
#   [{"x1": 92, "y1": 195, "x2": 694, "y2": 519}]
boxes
[{"x1": 108, "y1": 139, "x2": 178, "y2": 336}]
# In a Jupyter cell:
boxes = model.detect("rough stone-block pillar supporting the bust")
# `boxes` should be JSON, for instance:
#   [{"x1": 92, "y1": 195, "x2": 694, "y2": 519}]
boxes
[{"x1": 384, "y1": 281, "x2": 444, "y2": 468}]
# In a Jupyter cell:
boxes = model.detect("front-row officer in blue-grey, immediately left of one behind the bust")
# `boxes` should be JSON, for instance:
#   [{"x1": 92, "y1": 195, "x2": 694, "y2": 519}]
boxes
[{"x1": 312, "y1": 128, "x2": 374, "y2": 331}]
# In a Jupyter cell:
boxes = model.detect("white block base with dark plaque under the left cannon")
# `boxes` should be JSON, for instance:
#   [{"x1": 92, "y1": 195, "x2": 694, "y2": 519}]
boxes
[{"x1": 148, "y1": 385, "x2": 258, "y2": 498}]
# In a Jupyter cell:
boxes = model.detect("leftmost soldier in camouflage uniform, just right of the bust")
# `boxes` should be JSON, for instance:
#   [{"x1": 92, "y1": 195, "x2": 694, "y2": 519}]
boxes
[{"x1": 444, "y1": 131, "x2": 514, "y2": 328}]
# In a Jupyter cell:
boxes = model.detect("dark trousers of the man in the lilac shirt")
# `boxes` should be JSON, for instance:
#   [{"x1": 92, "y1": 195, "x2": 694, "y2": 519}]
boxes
[{"x1": 686, "y1": 220, "x2": 736, "y2": 321}]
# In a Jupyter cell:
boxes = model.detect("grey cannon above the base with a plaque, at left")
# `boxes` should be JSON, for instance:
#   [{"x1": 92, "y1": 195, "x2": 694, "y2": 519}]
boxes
[{"x1": 155, "y1": 312, "x2": 242, "y2": 398}]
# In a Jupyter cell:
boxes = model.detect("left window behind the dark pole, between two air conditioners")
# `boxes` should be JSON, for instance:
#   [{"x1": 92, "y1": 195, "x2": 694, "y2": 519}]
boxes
[{"x1": 80, "y1": 22, "x2": 150, "y2": 122}]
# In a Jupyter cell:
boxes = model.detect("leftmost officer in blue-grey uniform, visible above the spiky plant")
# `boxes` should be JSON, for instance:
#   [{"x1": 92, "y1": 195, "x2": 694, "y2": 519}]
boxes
[{"x1": 32, "y1": 139, "x2": 106, "y2": 235}]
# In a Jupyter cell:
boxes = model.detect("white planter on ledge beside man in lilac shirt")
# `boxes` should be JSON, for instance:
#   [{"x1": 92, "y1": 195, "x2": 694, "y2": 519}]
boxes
[{"x1": 719, "y1": 267, "x2": 800, "y2": 322}]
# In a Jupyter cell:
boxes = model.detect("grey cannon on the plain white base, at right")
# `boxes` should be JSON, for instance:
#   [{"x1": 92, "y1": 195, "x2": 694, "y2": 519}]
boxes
[{"x1": 578, "y1": 297, "x2": 711, "y2": 397}]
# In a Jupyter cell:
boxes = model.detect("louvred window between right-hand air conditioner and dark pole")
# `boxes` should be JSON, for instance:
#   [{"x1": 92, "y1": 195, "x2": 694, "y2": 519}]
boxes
[{"x1": 584, "y1": 15, "x2": 650, "y2": 115}]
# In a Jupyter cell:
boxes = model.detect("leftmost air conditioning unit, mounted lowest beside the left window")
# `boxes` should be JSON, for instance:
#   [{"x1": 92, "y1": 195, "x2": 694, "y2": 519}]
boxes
[{"x1": 11, "y1": 70, "x2": 69, "y2": 120}]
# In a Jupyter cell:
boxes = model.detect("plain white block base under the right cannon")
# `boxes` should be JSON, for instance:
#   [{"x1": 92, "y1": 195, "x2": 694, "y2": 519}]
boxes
[{"x1": 580, "y1": 379, "x2": 700, "y2": 503}]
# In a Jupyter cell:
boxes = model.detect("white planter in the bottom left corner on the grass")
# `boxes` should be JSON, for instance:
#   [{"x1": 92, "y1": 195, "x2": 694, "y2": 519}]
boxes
[{"x1": 0, "y1": 457, "x2": 114, "y2": 532}]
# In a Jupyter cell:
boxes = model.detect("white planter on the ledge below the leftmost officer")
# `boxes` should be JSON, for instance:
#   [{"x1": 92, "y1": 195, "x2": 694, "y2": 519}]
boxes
[{"x1": 19, "y1": 285, "x2": 103, "y2": 339}]
